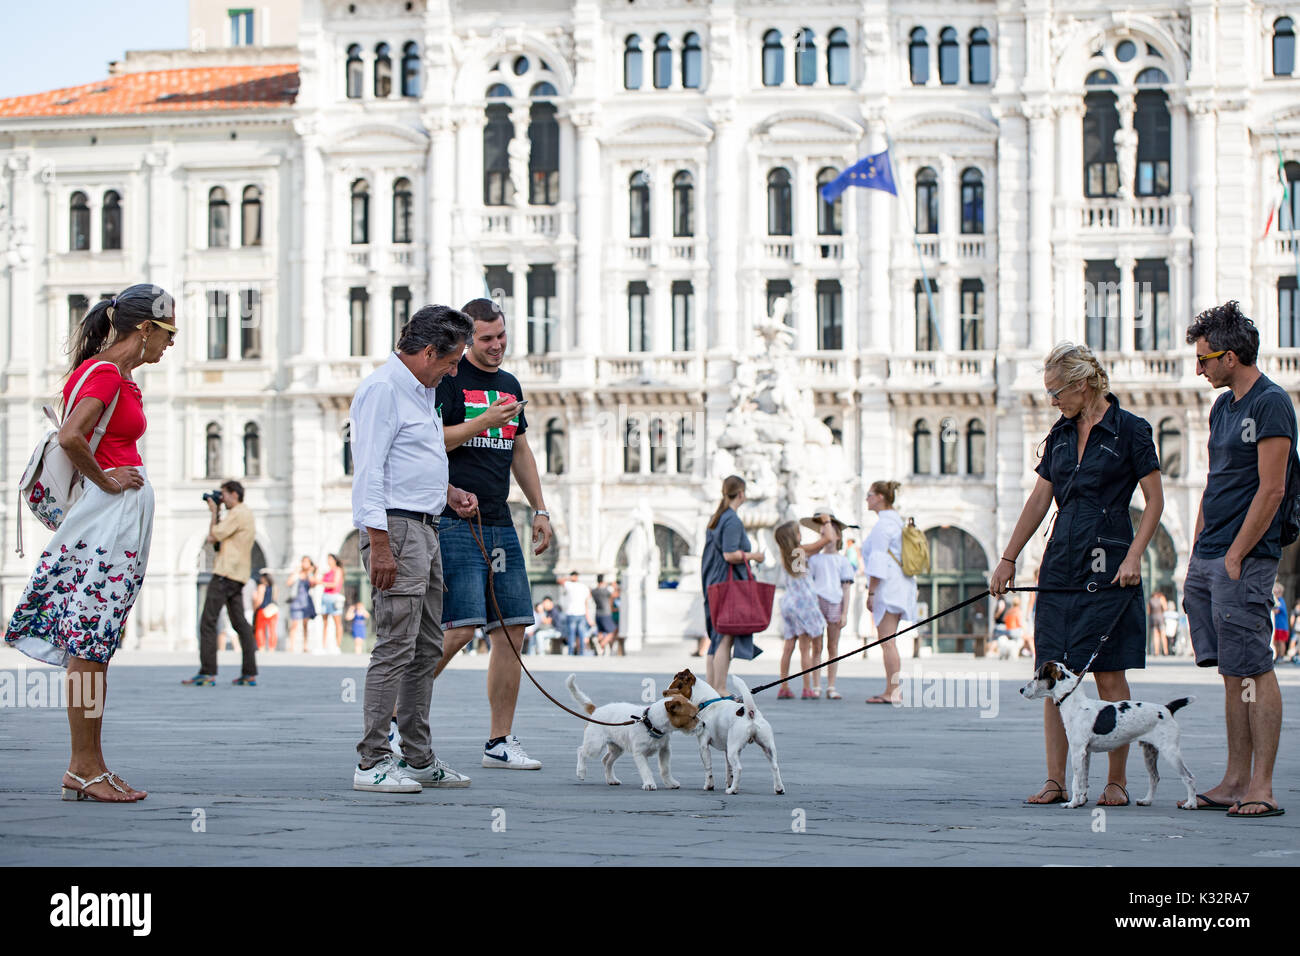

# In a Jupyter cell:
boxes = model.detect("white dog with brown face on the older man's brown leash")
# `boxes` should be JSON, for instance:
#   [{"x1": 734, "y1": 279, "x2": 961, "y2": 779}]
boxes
[{"x1": 564, "y1": 674, "x2": 699, "y2": 790}]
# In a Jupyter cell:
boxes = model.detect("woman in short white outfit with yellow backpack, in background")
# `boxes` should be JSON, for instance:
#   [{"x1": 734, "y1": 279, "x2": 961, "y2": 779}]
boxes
[{"x1": 862, "y1": 481, "x2": 917, "y2": 704}]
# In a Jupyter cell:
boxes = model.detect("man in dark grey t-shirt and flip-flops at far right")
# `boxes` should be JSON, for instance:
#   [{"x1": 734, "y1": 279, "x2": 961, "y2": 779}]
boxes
[{"x1": 1183, "y1": 302, "x2": 1296, "y2": 817}]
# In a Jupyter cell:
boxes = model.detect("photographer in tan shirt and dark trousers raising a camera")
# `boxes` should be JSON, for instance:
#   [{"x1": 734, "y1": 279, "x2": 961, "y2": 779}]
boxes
[{"x1": 181, "y1": 481, "x2": 257, "y2": 687}]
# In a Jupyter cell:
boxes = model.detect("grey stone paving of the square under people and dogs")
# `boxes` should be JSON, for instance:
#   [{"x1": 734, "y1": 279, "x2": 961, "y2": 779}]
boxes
[{"x1": 0, "y1": 644, "x2": 1300, "y2": 866}]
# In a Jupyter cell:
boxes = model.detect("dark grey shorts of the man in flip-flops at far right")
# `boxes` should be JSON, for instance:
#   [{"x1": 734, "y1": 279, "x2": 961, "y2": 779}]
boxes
[{"x1": 1183, "y1": 554, "x2": 1278, "y2": 678}]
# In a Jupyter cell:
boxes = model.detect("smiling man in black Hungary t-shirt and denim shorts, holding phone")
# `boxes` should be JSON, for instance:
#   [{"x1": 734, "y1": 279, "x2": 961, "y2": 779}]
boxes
[{"x1": 434, "y1": 299, "x2": 551, "y2": 770}]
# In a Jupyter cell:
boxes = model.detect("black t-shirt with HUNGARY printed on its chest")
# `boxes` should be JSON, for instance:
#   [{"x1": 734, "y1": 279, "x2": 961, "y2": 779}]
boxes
[{"x1": 437, "y1": 356, "x2": 528, "y2": 527}]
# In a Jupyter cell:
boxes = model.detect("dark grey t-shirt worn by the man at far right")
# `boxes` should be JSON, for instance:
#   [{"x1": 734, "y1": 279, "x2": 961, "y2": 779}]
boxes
[{"x1": 1196, "y1": 375, "x2": 1296, "y2": 558}]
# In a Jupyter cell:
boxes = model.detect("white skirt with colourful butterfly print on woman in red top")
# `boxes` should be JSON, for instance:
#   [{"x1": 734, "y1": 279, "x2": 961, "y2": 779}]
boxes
[{"x1": 5, "y1": 468, "x2": 153, "y2": 667}]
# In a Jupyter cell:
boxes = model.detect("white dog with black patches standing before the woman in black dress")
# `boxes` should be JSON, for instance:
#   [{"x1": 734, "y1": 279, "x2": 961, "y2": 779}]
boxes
[{"x1": 1021, "y1": 661, "x2": 1196, "y2": 810}]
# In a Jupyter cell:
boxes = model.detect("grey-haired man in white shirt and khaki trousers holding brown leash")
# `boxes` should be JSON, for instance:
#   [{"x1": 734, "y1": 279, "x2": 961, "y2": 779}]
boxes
[{"x1": 351, "y1": 306, "x2": 478, "y2": 793}]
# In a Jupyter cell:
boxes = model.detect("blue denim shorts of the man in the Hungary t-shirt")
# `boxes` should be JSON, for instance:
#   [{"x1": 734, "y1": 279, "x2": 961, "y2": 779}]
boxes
[{"x1": 438, "y1": 516, "x2": 533, "y2": 632}]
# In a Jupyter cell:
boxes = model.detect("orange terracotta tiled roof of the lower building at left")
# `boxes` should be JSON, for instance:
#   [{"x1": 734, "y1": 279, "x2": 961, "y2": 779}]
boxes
[{"x1": 0, "y1": 64, "x2": 298, "y2": 118}]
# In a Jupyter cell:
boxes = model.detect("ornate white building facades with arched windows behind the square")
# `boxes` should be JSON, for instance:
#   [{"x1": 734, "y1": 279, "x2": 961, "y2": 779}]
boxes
[{"x1": 0, "y1": 0, "x2": 1300, "y2": 648}]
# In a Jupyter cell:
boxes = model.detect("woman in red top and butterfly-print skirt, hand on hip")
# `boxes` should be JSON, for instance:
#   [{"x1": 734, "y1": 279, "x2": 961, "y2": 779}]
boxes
[{"x1": 5, "y1": 285, "x2": 177, "y2": 803}]
